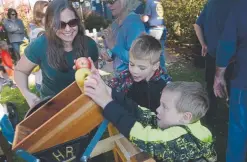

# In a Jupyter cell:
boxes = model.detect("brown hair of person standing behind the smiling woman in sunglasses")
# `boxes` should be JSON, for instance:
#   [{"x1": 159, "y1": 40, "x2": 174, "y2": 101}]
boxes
[{"x1": 33, "y1": 1, "x2": 49, "y2": 27}]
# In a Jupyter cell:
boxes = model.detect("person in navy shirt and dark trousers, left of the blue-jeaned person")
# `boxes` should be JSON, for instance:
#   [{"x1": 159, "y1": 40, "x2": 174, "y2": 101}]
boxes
[{"x1": 194, "y1": 0, "x2": 232, "y2": 121}]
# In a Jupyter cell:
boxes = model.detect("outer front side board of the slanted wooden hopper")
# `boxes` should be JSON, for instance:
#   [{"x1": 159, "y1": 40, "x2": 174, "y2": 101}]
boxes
[{"x1": 13, "y1": 94, "x2": 103, "y2": 153}]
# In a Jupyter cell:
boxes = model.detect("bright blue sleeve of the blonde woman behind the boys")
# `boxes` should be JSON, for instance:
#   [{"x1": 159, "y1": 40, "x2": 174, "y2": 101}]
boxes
[{"x1": 111, "y1": 22, "x2": 145, "y2": 64}]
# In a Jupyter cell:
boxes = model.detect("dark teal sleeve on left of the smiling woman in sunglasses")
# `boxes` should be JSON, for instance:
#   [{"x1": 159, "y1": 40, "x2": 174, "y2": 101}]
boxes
[{"x1": 24, "y1": 36, "x2": 45, "y2": 65}]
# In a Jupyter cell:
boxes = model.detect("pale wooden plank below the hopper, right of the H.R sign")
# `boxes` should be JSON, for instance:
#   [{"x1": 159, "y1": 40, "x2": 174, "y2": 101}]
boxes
[{"x1": 90, "y1": 134, "x2": 123, "y2": 158}]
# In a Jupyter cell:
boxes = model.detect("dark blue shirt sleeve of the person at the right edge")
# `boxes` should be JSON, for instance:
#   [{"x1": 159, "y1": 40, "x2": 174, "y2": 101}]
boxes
[{"x1": 216, "y1": 12, "x2": 237, "y2": 67}]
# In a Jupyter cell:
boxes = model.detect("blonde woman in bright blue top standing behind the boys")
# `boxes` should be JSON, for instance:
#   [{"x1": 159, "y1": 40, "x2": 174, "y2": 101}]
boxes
[{"x1": 102, "y1": 0, "x2": 145, "y2": 75}]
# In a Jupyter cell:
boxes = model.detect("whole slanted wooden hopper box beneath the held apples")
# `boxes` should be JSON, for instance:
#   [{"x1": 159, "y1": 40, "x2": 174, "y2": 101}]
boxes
[{"x1": 12, "y1": 82, "x2": 103, "y2": 153}]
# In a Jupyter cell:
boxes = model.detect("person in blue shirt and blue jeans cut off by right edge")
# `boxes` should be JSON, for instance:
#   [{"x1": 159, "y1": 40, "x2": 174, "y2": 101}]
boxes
[{"x1": 214, "y1": 0, "x2": 247, "y2": 162}]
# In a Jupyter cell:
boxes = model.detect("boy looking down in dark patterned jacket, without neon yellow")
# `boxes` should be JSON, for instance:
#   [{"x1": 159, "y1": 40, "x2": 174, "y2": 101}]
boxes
[{"x1": 109, "y1": 35, "x2": 171, "y2": 112}]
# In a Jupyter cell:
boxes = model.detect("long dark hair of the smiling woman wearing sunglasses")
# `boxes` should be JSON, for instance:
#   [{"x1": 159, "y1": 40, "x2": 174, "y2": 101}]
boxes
[{"x1": 45, "y1": 0, "x2": 88, "y2": 72}]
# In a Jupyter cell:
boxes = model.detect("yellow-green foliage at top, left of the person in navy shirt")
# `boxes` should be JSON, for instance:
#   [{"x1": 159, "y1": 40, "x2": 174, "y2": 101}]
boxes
[{"x1": 162, "y1": 0, "x2": 206, "y2": 44}]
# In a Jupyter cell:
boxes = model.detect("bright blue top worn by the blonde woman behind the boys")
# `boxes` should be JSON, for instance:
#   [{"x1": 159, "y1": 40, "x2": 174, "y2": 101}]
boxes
[{"x1": 111, "y1": 12, "x2": 146, "y2": 73}]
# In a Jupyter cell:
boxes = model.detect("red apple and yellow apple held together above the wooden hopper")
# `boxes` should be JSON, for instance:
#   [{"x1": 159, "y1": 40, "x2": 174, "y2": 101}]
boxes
[{"x1": 75, "y1": 57, "x2": 91, "y2": 88}]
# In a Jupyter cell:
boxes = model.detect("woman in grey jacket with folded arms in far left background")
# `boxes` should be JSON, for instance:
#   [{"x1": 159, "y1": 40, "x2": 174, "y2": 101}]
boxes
[{"x1": 4, "y1": 8, "x2": 25, "y2": 60}]
